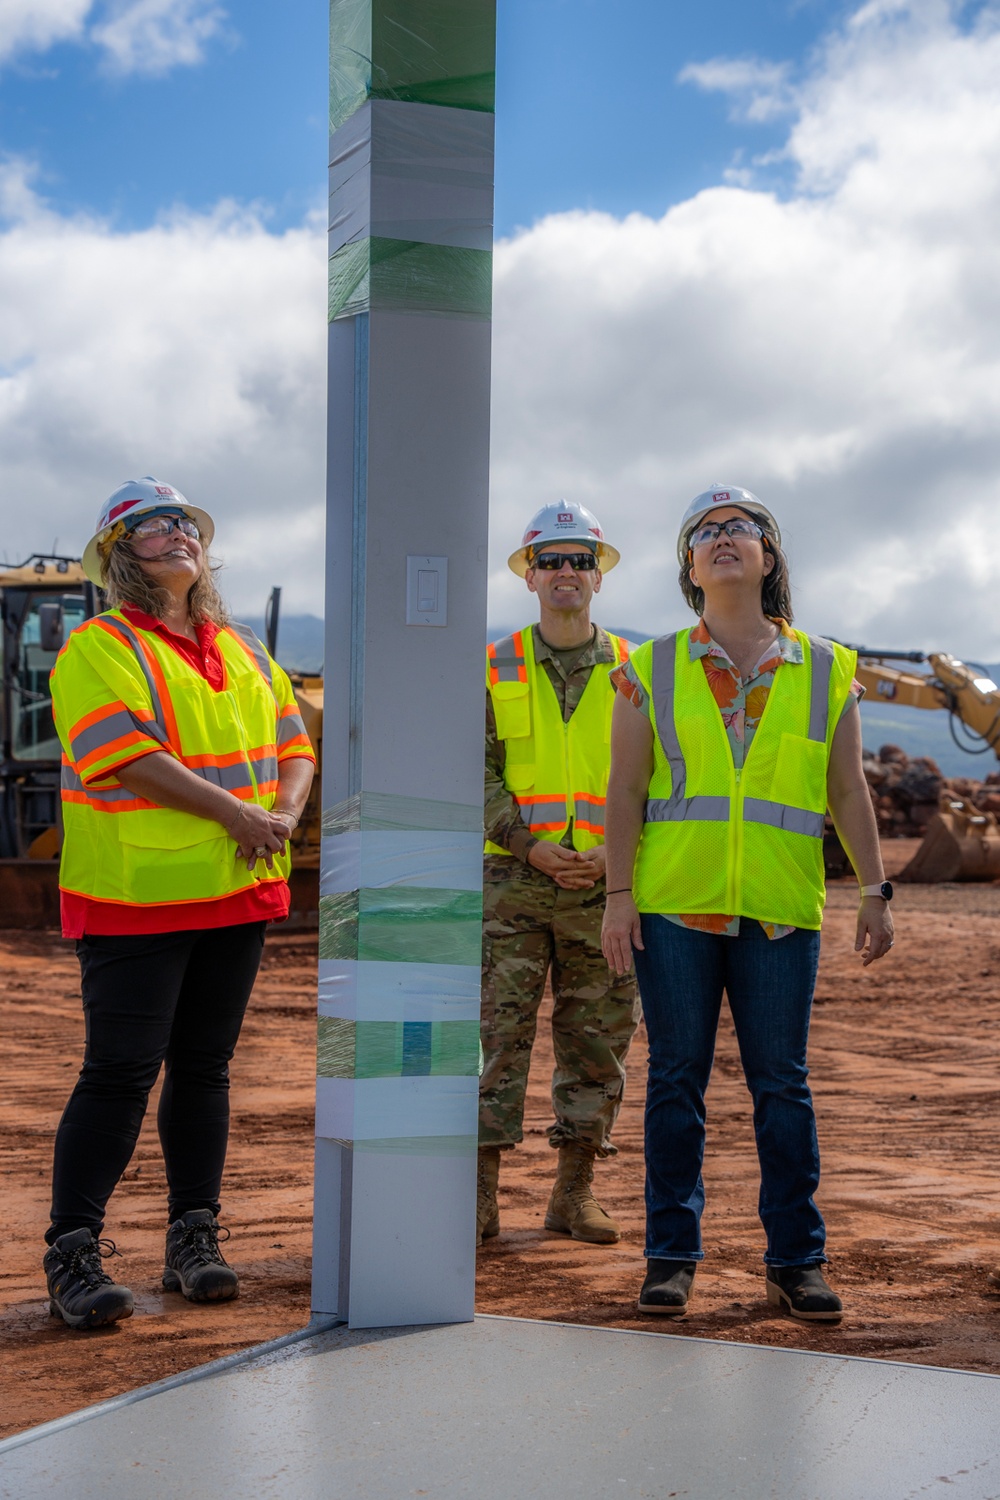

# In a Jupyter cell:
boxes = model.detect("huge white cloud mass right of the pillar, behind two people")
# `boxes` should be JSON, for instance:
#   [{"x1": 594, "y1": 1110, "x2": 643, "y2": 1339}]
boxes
[{"x1": 492, "y1": 0, "x2": 1000, "y2": 659}]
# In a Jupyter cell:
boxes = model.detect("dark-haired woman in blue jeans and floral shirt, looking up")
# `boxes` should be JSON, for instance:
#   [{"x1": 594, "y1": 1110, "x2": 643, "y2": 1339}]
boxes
[{"x1": 603, "y1": 488, "x2": 892, "y2": 1322}]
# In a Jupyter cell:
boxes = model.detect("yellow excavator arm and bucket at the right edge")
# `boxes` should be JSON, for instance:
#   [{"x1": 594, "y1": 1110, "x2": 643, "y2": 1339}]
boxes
[{"x1": 852, "y1": 647, "x2": 1000, "y2": 884}]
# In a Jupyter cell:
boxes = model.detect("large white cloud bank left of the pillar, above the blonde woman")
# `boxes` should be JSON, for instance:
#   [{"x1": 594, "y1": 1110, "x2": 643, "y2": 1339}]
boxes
[{"x1": 0, "y1": 164, "x2": 325, "y2": 614}]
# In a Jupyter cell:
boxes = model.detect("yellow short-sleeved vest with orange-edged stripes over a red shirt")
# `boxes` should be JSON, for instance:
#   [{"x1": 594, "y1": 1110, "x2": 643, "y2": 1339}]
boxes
[{"x1": 51, "y1": 611, "x2": 312, "y2": 906}]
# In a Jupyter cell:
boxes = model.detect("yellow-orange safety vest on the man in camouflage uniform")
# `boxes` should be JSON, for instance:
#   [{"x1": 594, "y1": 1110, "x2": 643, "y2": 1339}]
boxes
[{"x1": 486, "y1": 626, "x2": 628, "y2": 854}]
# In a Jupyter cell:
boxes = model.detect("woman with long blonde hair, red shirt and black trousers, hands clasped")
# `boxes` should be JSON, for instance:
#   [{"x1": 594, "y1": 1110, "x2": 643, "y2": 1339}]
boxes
[{"x1": 43, "y1": 476, "x2": 315, "y2": 1329}]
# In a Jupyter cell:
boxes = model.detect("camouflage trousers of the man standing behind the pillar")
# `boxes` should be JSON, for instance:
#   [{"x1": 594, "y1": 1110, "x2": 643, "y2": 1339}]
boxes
[{"x1": 480, "y1": 857, "x2": 639, "y2": 1157}]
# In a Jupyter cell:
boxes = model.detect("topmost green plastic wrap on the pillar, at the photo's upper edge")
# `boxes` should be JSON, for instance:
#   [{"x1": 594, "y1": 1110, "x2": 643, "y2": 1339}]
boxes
[{"x1": 330, "y1": 0, "x2": 496, "y2": 134}]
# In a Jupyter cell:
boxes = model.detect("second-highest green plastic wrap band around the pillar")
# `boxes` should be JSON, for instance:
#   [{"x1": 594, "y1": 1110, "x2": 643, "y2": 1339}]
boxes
[{"x1": 327, "y1": 237, "x2": 493, "y2": 323}]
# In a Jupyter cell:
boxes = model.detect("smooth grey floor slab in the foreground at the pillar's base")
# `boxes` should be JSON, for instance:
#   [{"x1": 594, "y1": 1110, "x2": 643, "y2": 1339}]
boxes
[{"x1": 0, "y1": 1317, "x2": 1000, "y2": 1500}]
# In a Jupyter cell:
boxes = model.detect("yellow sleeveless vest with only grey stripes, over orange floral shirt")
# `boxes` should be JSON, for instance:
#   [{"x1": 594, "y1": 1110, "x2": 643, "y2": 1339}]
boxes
[{"x1": 631, "y1": 630, "x2": 858, "y2": 929}]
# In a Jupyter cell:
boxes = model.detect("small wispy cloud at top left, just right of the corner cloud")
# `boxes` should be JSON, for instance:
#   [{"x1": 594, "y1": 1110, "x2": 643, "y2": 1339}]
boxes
[{"x1": 90, "y1": 0, "x2": 226, "y2": 75}]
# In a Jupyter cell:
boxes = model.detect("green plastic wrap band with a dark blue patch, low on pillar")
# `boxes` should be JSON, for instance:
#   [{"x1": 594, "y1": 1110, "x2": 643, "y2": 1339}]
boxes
[{"x1": 316, "y1": 1016, "x2": 480, "y2": 1079}]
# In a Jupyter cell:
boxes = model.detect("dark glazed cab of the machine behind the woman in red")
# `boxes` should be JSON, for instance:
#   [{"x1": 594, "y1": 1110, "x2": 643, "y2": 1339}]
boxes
[{"x1": 0, "y1": 557, "x2": 97, "y2": 860}]
